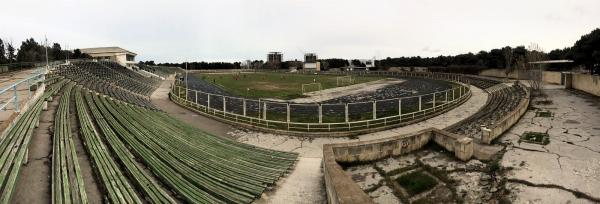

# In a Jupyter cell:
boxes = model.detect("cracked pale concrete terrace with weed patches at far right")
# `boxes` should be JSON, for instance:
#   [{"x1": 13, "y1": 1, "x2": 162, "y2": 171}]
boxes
[{"x1": 498, "y1": 85, "x2": 600, "y2": 203}]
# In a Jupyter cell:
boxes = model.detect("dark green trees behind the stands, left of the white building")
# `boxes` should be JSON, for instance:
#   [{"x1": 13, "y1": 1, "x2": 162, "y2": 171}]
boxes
[{"x1": 0, "y1": 38, "x2": 91, "y2": 64}]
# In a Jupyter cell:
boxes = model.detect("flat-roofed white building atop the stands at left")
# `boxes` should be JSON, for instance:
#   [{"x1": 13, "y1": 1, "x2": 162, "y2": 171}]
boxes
[{"x1": 81, "y1": 47, "x2": 137, "y2": 68}]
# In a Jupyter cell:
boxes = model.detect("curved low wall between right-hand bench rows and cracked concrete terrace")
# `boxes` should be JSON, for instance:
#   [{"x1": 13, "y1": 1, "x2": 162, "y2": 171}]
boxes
[{"x1": 481, "y1": 85, "x2": 530, "y2": 144}]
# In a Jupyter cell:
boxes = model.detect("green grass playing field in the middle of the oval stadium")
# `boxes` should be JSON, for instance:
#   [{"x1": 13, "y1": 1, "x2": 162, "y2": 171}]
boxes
[{"x1": 194, "y1": 73, "x2": 384, "y2": 100}]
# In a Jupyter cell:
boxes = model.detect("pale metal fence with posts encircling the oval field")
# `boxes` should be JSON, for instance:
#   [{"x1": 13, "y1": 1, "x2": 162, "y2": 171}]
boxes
[{"x1": 170, "y1": 72, "x2": 471, "y2": 135}]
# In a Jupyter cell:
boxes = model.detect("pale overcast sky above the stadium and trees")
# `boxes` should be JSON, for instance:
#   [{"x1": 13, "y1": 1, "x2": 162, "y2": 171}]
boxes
[{"x1": 0, "y1": 0, "x2": 600, "y2": 62}]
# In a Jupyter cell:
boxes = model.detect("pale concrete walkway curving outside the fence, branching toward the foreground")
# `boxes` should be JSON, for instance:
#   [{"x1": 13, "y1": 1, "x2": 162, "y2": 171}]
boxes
[{"x1": 151, "y1": 77, "x2": 488, "y2": 203}]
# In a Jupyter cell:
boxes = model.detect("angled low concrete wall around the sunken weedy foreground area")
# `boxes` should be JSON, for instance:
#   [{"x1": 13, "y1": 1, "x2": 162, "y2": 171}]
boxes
[{"x1": 323, "y1": 128, "x2": 474, "y2": 203}]
